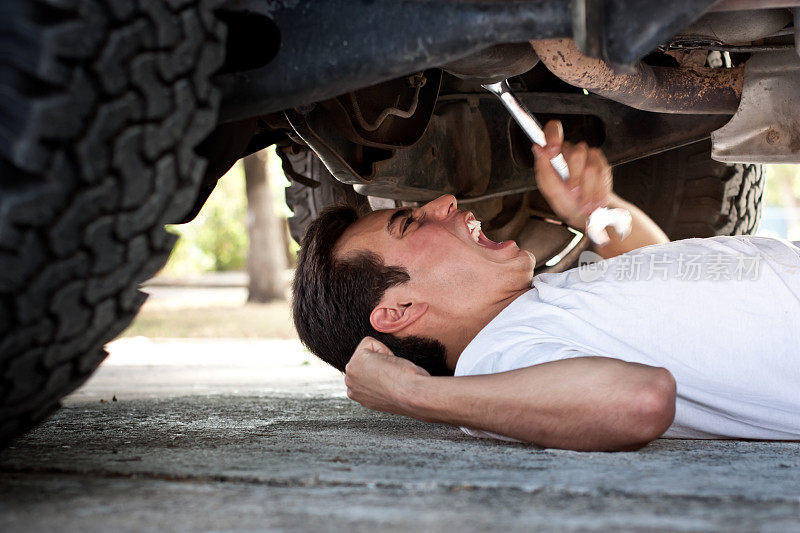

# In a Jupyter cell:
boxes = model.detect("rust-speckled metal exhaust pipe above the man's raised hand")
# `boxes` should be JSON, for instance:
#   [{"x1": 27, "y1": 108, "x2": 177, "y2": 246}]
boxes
[{"x1": 531, "y1": 39, "x2": 743, "y2": 115}]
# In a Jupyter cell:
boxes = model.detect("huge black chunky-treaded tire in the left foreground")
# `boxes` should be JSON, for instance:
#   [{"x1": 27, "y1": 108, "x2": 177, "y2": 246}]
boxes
[{"x1": 0, "y1": 0, "x2": 224, "y2": 443}]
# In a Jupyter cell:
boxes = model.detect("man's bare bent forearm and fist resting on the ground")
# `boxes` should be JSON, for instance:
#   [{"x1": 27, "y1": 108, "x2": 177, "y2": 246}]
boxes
[{"x1": 345, "y1": 337, "x2": 675, "y2": 451}]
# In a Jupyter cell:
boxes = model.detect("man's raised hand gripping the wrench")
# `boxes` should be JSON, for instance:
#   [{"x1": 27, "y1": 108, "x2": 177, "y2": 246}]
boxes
[{"x1": 533, "y1": 120, "x2": 612, "y2": 231}]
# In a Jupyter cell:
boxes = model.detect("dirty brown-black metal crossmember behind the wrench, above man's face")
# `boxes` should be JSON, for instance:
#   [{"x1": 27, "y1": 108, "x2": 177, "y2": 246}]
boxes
[{"x1": 286, "y1": 92, "x2": 730, "y2": 201}]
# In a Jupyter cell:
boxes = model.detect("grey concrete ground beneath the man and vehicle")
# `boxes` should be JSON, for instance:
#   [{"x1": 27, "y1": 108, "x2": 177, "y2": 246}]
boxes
[{"x1": 0, "y1": 338, "x2": 800, "y2": 532}]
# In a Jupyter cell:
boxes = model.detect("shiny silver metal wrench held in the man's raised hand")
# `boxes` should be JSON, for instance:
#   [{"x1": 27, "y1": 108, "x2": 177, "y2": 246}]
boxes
[{"x1": 482, "y1": 80, "x2": 631, "y2": 246}]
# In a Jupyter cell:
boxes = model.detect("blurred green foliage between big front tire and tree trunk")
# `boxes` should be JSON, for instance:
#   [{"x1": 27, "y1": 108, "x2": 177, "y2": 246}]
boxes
[{"x1": 164, "y1": 161, "x2": 248, "y2": 275}]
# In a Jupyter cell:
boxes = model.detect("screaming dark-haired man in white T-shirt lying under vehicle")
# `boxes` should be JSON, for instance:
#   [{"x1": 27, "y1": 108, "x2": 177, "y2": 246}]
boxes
[{"x1": 293, "y1": 123, "x2": 800, "y2": 450}]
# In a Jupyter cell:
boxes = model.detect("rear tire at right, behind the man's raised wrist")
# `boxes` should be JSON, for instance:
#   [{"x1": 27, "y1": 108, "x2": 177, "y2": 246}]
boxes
[{"x1": 614, "y1": 140, "x2": 764, "y2": 240}]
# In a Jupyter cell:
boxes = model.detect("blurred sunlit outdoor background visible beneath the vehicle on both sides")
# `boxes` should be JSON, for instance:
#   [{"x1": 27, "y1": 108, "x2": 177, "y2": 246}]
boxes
[{"x1": 123, "y1": 158, "x2": 800, "y2": 339}]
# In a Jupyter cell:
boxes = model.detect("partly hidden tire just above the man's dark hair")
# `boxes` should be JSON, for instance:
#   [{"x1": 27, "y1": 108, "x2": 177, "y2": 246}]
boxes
[{"x1": 278, "y1": 144, "x2": 369, "y2": 242}]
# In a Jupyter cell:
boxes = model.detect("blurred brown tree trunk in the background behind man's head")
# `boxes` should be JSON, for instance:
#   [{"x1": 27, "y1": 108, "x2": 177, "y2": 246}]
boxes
[{"x1": 244, "y1": 150, "x2": 287, "y2": 302}]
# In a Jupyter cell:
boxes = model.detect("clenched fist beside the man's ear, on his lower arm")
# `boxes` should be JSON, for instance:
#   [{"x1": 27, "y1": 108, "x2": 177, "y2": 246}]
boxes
[{"x1": 344, "y1": 337, "x2": 430, "y2": 416}]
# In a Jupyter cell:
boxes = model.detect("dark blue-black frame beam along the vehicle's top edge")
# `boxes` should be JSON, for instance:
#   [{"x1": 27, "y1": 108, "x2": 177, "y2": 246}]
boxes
[{"x1": 217, "y1": 0, "x2": 714, "y2": 122}]
